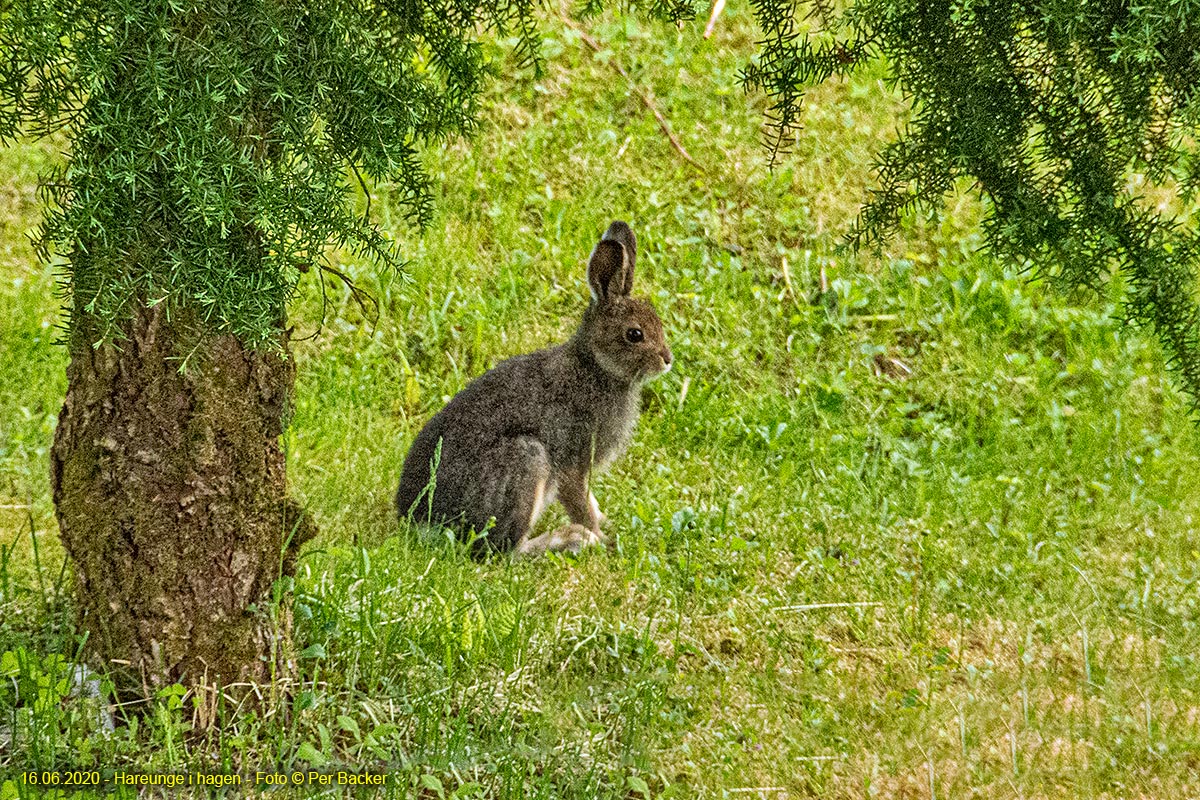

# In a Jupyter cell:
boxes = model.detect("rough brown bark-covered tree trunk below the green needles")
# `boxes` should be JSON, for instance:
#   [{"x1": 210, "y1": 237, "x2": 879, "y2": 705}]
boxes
[{"x1": 50, "y1": 306, "x2": 314, "y2": 698}]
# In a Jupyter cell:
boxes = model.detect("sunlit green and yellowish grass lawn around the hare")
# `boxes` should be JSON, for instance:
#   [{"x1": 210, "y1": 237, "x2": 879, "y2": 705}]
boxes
[{"x1": 0, "y1": 2, "x2": 1200, "y2": 798}]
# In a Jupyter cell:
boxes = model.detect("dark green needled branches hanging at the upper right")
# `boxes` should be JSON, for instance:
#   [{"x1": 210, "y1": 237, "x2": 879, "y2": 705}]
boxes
[{"x1": 745, "y1": 0, "x2": 1200, "y2": 409}]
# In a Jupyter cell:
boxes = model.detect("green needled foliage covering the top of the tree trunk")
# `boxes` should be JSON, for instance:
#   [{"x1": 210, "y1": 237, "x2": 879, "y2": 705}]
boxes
[{"x1": 0, "y1": 0, "x2": 686, "y2": 345}]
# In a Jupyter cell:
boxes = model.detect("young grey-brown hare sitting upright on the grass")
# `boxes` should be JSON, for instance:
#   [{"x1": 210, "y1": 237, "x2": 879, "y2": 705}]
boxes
[{"x1": 396, "y1": 222, "x2": 671, "y2": 555}]
